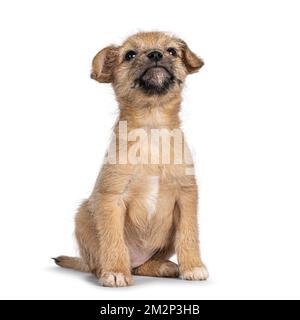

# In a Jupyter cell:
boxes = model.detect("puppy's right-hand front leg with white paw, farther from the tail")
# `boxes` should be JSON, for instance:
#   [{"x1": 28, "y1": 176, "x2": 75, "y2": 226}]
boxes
[{"x1": 175, "y1": 183, "x2": 208, "y2": 280}]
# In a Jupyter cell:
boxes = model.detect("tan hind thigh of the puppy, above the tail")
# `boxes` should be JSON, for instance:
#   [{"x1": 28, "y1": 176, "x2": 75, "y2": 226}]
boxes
[{"x1": 75, "y1": 200, "x2": 99, "y2": 276}]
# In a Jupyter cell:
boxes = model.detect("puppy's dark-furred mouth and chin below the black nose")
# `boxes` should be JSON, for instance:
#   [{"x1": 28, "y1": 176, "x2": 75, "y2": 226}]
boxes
[{"x1": 134, "y1": 65, "x2": 175, "y2": 95}]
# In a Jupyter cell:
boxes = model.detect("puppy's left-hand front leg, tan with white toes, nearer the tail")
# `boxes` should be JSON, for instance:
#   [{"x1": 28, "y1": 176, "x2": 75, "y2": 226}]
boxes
[{"x1": 95, "y1": 194, "x2": 132, "y2": 287}]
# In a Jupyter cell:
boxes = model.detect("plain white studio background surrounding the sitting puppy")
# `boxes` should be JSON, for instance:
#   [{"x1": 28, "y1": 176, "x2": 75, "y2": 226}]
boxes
[{"x1": 0, "y1": 0, "x2": 300, "y2": 299}]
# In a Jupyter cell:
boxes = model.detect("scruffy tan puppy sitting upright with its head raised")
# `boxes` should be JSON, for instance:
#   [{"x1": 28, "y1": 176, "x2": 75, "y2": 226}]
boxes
[{"x1": 55, "y1": 32, "x2": 208, "y2": 287}]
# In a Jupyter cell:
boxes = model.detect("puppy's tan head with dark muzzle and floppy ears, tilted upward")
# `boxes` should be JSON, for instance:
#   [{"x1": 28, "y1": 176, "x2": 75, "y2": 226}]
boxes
[{"x1": 91, "y1": 32, "x2": 203, "y2": 103}]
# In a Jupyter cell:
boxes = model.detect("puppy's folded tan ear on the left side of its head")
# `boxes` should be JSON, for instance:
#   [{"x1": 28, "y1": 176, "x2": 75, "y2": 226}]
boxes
[{"x1": 91, "y1": 46, "x2": 119, "y2": 83}]
